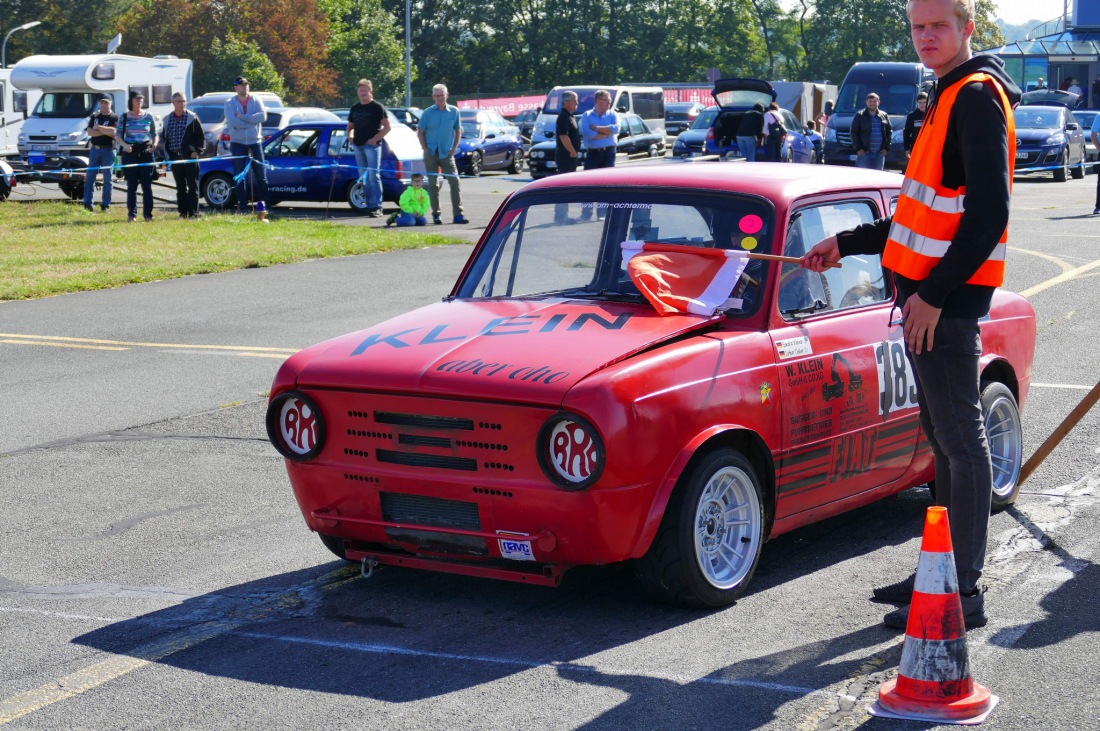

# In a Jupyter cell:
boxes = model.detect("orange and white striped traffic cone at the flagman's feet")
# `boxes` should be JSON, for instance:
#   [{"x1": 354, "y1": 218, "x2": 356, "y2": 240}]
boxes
[{"x1": 872, "y1": 506, "x2": 998, "y2": 723}]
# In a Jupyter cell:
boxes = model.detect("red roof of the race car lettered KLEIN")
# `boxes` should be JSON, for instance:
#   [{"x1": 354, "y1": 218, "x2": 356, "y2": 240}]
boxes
[{"x1": 521, "y1": 163, "x2": 903, "y2": 204}]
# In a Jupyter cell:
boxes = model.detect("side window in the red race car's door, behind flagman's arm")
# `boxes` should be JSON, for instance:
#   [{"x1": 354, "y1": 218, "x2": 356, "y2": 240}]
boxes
[{"x1": 779, "y1": 201, "x2": 891, "y2": 319}]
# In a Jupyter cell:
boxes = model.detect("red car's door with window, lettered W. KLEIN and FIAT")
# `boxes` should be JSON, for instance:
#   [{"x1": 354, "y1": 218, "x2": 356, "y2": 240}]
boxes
[{"x1": 772, "y1": 198, "x2": 920, "y2": 513}]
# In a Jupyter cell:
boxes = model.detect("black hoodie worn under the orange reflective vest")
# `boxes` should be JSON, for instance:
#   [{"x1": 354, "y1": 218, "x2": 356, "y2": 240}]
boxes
[{"x1": 837, "y1": 55, "x2": 1020, "y2": 318}]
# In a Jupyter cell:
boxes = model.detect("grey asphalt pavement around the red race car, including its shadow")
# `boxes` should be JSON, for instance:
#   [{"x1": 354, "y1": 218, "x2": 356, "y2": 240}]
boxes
[{"x1": 0, "y1": 160, "x2": 1100, "y2": 731}]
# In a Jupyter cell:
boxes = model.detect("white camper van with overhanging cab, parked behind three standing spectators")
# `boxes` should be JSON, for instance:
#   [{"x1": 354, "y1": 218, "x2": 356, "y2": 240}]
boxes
[{"x1": 11, "y1": 54, "x2": 191, "y2": 197}]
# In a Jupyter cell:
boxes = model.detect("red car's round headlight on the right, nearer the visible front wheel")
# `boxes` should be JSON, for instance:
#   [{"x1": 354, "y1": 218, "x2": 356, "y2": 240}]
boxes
[{"x1": 537, "y1": 412, "x2": 607, "y2": 490}]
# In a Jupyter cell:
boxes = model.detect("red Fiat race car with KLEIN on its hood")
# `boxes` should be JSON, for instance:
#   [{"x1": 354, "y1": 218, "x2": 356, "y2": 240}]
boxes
[{"x1": 267, "y1": 164, "x2": 1035, "y2": 607}]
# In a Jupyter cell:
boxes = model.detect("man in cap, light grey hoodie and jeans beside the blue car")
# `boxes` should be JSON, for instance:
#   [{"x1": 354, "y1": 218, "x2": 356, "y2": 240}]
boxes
[{"x1": 226, "y1": 76, "x2": 267, "y2": 223}]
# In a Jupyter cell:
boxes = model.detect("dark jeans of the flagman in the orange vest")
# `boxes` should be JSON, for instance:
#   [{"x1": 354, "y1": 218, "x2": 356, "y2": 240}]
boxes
[{"x1": 906, "y1": 314, "x2": 993, "y2": 592}]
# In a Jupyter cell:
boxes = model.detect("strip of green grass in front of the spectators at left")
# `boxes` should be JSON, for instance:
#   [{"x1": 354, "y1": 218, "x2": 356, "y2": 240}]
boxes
[{"x1": 0, "y1": 201, "x2": 468, "y2": 300}]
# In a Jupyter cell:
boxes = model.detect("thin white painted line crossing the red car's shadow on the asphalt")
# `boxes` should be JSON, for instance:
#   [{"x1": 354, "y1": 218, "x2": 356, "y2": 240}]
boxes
[{"x1": 231, "y1": 630, "x2": 837, "y2": 697}]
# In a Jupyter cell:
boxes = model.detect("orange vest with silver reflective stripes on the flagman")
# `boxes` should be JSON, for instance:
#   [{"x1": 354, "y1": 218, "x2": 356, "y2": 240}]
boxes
[{"x1": 882, "y1": 73, "x2": 1016, "y2": 287}]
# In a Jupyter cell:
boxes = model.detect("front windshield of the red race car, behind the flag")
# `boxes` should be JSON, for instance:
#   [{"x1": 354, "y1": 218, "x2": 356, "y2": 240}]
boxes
[{"x1": 458, "y1": 189, "x2": 774, "y2": 314}]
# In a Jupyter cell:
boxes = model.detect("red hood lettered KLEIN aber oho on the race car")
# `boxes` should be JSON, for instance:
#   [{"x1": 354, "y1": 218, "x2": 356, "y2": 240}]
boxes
[{"x1": 293, "y1": 299, "x2": 723, "y2": 403}]
